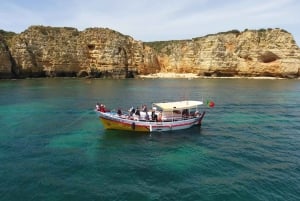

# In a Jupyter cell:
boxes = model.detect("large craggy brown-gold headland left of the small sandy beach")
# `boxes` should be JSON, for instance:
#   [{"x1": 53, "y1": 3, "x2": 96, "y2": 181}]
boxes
[{"x1": 3, "y1": 26, "x2": 159, "y2": 78}]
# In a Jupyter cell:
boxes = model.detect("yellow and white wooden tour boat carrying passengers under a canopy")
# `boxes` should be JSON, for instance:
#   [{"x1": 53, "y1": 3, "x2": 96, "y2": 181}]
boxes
[{"x1": 95, "y1": 100, "x2": 205, "y2": 132}]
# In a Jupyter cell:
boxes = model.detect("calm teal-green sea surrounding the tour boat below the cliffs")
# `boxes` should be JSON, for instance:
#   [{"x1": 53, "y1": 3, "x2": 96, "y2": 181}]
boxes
[{"x1": 0, "y1": 79, "x2": 300, "y2": 201}]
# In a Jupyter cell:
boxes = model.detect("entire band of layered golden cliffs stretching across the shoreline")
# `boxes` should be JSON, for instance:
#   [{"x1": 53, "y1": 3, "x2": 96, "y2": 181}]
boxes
[{"x1": 0, "y1": 26, "x2": 300, "y2": 78}]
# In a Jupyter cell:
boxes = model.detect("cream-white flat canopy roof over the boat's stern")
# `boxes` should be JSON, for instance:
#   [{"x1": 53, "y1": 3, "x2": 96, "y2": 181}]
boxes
[{"x1": 153, "y1": 100, "x2": 203, "y2": 111}]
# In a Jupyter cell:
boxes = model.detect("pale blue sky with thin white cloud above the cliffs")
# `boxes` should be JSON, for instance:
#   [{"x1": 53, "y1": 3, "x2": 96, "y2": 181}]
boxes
[{"x1": 0, "y1": 0, "x2": 300, "y2": 45}]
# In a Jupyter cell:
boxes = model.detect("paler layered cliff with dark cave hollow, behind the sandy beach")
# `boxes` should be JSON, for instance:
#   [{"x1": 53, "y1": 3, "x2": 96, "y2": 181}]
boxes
[{"x1": 148, "y1": 29, "x2": 300, "y2": 78}]
